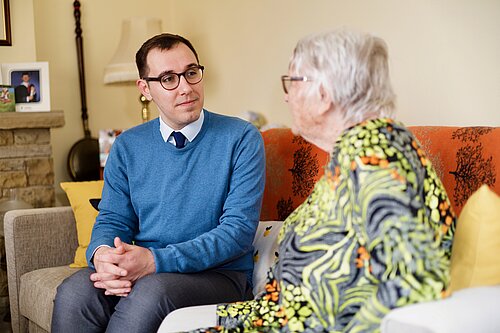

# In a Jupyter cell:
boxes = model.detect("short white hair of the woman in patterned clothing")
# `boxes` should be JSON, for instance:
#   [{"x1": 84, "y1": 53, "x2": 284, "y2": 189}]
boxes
[{"x1": 290, "y1": 30, "x2": 396, "y2": 123}]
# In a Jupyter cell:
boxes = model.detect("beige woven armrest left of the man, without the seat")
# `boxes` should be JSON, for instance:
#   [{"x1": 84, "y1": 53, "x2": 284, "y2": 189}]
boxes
[{"x1": 4, "y1": 207, "x2": 78, "y2": 331}]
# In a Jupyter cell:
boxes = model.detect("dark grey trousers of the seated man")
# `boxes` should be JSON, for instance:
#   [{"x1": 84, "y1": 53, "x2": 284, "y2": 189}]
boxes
[{"x1": 51, "y1": 268, "x2": 252, "y2": 333}]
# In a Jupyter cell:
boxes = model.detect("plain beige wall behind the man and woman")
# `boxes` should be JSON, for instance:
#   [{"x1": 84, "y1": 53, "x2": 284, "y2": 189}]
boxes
[{"x1": 0, "y1": 0, "x2": 500, "y2": 202}]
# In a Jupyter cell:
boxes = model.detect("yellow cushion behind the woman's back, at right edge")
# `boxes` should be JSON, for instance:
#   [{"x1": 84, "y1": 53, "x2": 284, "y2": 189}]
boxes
[{"x1": 449, "y1": 185, "x2": 500, "y2": 292}]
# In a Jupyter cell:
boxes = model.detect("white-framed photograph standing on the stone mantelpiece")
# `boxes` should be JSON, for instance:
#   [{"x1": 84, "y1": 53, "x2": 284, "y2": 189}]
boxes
[{"x1": 2, "y1": 62, "x2": 50, "y2": 112}]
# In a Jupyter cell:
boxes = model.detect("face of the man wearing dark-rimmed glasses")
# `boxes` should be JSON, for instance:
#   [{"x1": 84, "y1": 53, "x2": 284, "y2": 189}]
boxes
[{"x1": 137, "y1": 43, "x2": 204, "y2": 130}]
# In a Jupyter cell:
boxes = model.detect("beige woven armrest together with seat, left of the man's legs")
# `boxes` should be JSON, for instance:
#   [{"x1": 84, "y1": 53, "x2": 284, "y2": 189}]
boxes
[{"x1": 4, "y1": 207, "x2": 82, "y2": 333}]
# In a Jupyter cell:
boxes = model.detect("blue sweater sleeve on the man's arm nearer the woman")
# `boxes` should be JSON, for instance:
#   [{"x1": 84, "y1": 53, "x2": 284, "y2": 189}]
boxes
[{"x1": 150, "y1": 124, "x2": 265, "y2": 278}]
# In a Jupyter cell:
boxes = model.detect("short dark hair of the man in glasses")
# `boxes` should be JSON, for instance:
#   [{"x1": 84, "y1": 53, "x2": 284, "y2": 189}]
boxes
[{"x1": 135, "y1": 33, "x2": 200, "y2": 78}]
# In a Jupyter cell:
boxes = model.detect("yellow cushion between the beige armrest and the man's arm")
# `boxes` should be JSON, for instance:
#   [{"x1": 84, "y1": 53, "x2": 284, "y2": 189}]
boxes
[{"x1": 61, "y1": 180, "x2": 104, "y2": 267}]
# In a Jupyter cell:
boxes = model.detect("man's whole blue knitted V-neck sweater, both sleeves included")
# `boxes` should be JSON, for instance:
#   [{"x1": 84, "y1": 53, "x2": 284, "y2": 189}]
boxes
[{"x1": 87, "y1": 110, "x2": 265, "y2": 282}]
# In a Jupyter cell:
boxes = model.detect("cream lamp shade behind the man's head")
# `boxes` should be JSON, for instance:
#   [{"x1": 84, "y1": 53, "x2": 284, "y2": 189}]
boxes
[{"x1": 104, "y1": 17, "x2": 161, "y2": 84}]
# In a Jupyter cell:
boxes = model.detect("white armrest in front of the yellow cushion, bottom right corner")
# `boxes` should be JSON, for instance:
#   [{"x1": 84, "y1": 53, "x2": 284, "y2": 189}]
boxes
[{"x1": 381, "y1": 285, "x2": 500, "y2": 333}]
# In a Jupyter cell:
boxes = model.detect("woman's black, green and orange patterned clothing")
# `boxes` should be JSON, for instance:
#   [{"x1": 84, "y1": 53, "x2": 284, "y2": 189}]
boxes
[{"x1": 191, "y1": 119, "x2": 455, "y2": 332}]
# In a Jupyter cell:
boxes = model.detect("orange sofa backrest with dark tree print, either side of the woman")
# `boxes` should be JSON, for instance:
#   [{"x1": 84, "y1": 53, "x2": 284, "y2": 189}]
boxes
[{"x1": 261, "y1": 126, "x2": 500, "y2": 221}]
